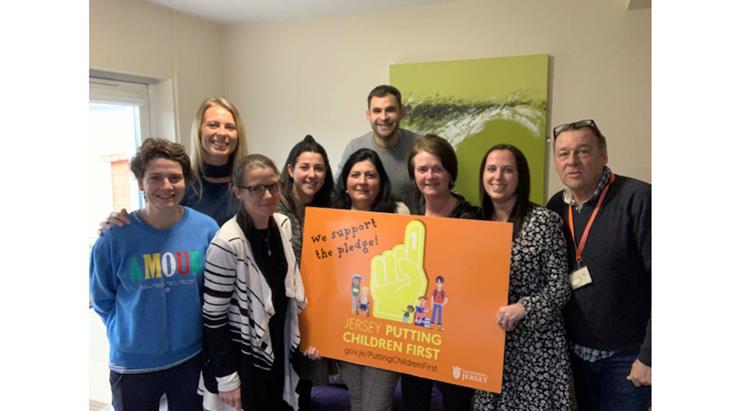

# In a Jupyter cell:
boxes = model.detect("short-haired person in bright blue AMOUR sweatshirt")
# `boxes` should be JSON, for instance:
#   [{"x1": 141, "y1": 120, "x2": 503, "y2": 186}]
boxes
[{"x1": 89, "y1": 138, "x2": 218, "y2": 411}]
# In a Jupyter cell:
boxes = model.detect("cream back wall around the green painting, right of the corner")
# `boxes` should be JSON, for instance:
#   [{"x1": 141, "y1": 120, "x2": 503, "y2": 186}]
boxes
[{"x1": 223, "y1": 0, "x2": 651, "y2": 200}]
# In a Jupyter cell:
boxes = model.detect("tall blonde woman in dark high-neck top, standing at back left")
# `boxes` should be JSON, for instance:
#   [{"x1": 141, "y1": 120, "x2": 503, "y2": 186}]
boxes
[{"x1": 100, "y1": 97, "x2": 247, "y2": 230}]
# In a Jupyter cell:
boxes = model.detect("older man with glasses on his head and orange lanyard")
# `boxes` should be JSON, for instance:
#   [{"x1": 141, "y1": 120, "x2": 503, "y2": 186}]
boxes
[{"x1": 547, "y1": 120, "x2": 651, "y2": 411}]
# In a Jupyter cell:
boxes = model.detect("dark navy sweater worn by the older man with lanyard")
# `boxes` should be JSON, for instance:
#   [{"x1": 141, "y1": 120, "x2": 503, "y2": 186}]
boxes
[{"x1": 547, "y1": 175, "x2": 651, "y2": 365}]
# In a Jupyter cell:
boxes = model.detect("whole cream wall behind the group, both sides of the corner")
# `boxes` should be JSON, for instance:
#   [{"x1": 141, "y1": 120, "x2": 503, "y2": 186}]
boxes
[{"x1": 90, "y1": 0, "x2": 651, "y2": 195}]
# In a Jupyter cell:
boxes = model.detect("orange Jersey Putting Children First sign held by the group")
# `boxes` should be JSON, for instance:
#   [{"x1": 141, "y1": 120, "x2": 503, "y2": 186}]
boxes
[{"x1": 300, "y1": 207, "x2": 513, "y2": 393}]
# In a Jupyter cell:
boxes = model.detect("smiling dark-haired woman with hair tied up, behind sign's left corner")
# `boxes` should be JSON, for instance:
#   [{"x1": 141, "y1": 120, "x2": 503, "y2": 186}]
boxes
[{"x1": 277, "y1": 135, "x2": 336, "y2": 411}]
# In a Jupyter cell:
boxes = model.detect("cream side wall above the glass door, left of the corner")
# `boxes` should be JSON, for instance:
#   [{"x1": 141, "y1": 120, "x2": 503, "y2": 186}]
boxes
[{"x1": 89, "y1": 0, "x2": 224, "y2": 147}]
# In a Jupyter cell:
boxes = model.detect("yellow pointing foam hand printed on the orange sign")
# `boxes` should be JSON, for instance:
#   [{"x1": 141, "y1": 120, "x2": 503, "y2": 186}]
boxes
[{"x1": 370, "y1": 220, "x2": 427, "y2": 321}]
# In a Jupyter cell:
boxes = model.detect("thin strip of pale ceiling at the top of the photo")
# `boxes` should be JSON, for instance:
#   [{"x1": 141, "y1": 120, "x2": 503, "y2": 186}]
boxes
[{"x1": 147, "y1": 0, "x2": 468, "y2": 24}]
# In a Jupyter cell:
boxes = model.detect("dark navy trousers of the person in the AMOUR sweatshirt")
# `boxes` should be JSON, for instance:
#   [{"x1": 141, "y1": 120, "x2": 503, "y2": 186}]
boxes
[{"x1": 109, "y1": 354, "x2": 203, "y2": 411}]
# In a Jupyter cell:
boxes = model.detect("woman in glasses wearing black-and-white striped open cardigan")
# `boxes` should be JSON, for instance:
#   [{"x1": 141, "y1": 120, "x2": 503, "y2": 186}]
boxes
[{"x1": 201, "y1": 154, "x2": 318, "y2": 411}]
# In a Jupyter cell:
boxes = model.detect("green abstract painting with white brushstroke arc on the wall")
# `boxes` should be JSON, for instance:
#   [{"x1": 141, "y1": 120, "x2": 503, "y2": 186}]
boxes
[{"x1": 390, "y1": 55, "x2": 549, "y2": 204}]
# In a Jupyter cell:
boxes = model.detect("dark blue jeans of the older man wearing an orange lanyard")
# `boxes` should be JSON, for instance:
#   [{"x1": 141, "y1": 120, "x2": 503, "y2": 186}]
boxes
[{"x1": 570, "y1": 353, "x2": 651, "y2": 411}]
